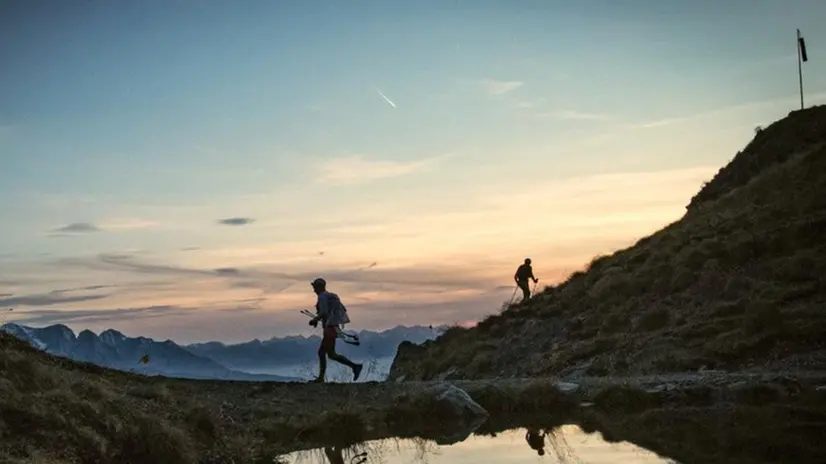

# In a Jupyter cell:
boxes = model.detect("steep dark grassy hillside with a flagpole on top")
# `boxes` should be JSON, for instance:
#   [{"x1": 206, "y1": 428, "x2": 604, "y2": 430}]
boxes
[{"x1": 390, "y1": 106, "x2": 826, "y2": 380}]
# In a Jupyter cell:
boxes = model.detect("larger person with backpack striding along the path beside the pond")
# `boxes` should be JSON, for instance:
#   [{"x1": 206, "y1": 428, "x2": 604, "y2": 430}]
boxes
[{"x1": 310, "y1": 277, "x2": 362, "y2": 382}]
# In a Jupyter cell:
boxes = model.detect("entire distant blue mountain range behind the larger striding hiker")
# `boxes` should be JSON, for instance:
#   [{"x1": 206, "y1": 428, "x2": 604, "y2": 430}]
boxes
[{"x1": 0, "y1": 323, "x2": 446, "y2": 382}]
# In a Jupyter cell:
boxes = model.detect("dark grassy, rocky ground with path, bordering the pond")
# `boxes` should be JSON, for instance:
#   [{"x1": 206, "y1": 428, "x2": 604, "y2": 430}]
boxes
[{"x1": 0, "y1": 328, "x2": 826, "y2": 463}]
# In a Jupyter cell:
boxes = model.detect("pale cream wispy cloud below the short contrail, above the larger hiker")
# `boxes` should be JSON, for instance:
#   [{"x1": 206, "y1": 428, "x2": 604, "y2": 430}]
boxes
[{"x1": 320, "y1": 155, "x2": 444, "y2": 184}]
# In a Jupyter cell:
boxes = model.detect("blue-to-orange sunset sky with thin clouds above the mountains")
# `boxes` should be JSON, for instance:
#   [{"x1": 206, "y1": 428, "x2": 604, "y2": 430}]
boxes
[{"x1": 0, "y1": 0, "x2": 826, "y2": 343}]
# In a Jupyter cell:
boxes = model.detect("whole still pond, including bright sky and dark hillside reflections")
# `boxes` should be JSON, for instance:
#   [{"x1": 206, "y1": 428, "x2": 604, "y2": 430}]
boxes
[{"x1": 279, "y1": 396, "x2": 826, "y2": 464}]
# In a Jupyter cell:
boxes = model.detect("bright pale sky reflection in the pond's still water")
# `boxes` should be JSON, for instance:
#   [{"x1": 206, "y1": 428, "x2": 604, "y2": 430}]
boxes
[{"x1": 282, "y1": 425, "x2": 675, "y2": 464}]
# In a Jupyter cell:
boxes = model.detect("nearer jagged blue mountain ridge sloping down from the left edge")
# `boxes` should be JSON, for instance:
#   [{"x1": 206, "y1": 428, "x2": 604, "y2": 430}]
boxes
[{"x1": 0, "y1": 323, "x2": 298, "y2": 381}]
